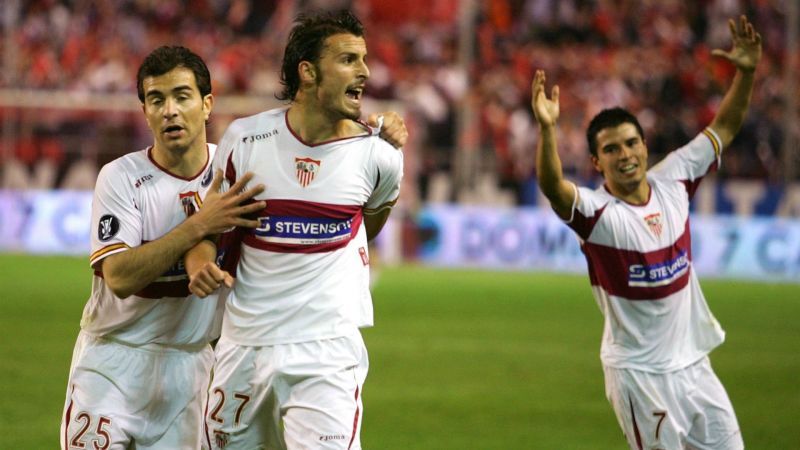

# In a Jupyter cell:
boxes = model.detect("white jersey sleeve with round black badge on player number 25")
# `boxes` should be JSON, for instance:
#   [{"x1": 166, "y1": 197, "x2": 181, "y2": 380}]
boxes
[{"x1": 89, "y1": 160, "x2": 143, "y2": 267}]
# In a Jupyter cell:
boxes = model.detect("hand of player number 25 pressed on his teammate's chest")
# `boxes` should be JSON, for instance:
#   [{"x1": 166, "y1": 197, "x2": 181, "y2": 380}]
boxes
[{"x1": 190, "y1": 170, "x2": 267, "y2": 236}]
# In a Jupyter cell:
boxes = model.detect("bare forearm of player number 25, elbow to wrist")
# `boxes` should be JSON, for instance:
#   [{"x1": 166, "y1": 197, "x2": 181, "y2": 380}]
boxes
[{"x1": 103, "y1": 222, "x2": 203, "y2": 298}]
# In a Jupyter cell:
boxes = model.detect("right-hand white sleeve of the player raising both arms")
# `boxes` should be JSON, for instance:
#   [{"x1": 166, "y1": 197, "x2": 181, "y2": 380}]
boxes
[{"x1": 651, "y1": 128, "x2": 722, "y2": 189}]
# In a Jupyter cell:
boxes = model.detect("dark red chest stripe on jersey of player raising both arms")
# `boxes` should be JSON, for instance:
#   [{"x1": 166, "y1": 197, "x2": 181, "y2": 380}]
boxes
[{"x1": 581, "y1": 220, "x2": 692, "y2": 300}]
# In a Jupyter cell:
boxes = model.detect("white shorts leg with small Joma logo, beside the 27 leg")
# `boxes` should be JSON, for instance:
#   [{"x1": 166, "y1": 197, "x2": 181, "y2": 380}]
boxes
[{"x1": 283, "y1": 336, "x2": 368, "y2": 450}]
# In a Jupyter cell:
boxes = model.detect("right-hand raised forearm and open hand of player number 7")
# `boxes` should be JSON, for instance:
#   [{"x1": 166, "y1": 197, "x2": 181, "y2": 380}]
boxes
[{"x1": 710, "y1": 16, "x2": 761, "y2": 147}]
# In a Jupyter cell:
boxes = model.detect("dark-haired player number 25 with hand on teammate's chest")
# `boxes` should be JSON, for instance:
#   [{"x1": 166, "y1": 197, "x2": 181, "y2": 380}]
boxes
[{"x1": 60, "y1": 47, "x2": 264, "y2": 450}]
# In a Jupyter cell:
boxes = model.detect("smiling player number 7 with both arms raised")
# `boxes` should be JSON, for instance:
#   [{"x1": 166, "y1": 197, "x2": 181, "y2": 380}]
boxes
[{"x1": 531, "y1": 16, "x2": 761, "y2": 450}]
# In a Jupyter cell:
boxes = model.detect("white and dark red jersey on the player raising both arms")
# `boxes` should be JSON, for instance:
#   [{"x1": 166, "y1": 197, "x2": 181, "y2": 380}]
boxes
[{"x1": 568, "y1": 128, "x2": 725, "y2": 373}]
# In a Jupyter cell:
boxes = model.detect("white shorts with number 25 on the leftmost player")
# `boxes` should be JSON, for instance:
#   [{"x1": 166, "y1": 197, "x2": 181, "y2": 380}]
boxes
[{"x1": 59, "y1": 332, "x2": 214, "y2": 450}]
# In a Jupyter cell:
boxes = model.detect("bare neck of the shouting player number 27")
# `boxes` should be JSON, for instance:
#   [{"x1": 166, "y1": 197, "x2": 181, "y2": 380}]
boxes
[{"x1": 287, "y1": 102, "x2": 365, "y2": 144}]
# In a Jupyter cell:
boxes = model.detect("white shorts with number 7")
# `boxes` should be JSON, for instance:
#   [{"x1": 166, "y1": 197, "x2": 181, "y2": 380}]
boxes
[{"x1": 604, "y1": 357, "x2": 744, "y2": 450}]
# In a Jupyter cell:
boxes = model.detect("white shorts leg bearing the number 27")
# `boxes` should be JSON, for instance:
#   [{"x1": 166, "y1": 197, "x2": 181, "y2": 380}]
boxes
[{"x1": 205, "y1": 340, "x2": 285, "y2": 450}]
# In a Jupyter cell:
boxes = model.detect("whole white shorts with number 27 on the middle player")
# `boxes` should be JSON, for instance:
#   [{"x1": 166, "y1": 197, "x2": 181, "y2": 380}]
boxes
[{"x1": 206, "y1": 332, "x2": 369, "y2": 450}]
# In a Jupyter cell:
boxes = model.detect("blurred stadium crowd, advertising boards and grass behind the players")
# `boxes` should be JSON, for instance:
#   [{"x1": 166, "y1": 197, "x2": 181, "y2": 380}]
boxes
[{"x1": 0, "y1": 0, "x2": 800, "y2": 450}]
